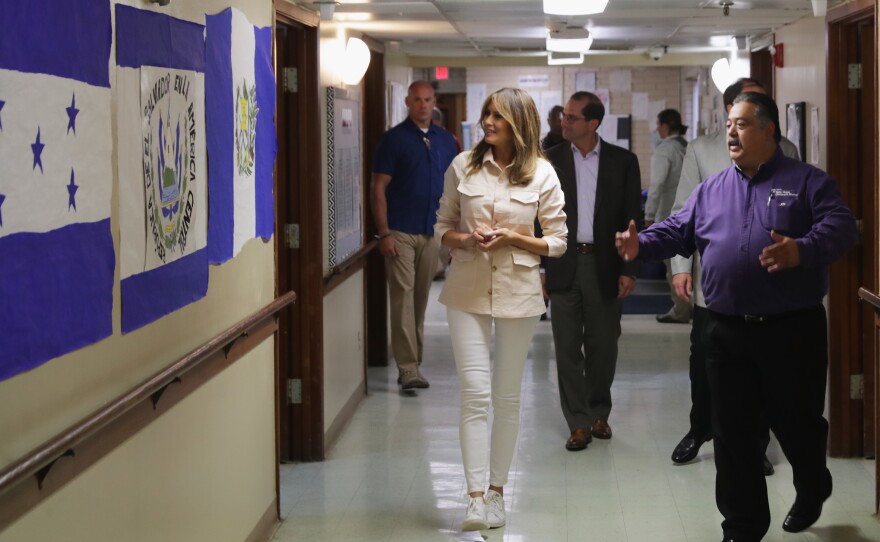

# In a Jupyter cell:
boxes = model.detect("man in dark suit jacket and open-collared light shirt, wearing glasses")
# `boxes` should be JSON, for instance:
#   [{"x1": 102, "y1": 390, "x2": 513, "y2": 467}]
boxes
[{"x1": 543, "y1": 92, "x2": 641, "y2": 451}]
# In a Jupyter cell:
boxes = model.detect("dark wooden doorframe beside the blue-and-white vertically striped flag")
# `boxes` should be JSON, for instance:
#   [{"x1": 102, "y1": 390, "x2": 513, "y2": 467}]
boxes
[{"x1": 275, "y1": 0, "x2": 324, "y2": 461}]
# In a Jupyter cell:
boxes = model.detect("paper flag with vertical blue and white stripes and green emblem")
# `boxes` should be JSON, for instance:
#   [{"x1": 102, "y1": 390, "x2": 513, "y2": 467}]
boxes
[{"x1": 205, "y1": 8, "x2": 278, "y2": 263}]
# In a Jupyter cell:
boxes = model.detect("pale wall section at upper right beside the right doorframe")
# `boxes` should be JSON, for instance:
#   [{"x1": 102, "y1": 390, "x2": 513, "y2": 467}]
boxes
[{"x1": 774, "y1": 17, "x2": 828, "y2": 169}]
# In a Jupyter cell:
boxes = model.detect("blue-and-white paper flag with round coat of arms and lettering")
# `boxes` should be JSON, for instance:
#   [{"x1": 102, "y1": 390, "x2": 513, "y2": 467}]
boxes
[{"x1": 116, "y1": 4, "x2": 208, "y2": 333}]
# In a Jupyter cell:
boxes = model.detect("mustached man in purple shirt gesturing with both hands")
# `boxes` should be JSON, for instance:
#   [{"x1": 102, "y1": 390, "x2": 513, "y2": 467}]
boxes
[{"x1": 616, "y1": 92, "x2": 856, "y2": 542}]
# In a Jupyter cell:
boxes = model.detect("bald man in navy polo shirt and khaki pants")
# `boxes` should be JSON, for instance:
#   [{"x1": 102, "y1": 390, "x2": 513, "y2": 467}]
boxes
[{"x1": 371, "y1": 81, "x2": 456, "y2": 390}]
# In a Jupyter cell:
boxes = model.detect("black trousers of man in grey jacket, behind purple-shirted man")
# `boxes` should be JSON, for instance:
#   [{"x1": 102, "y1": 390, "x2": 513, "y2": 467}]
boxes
[{"x1": 688, "y1": 305, "x2": 770, "y2": 453}]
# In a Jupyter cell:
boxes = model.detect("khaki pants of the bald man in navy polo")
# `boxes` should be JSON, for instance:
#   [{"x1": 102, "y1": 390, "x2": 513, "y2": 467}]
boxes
[{"x1": 385, "y1": 231, "x2": 439, "y2": 372}]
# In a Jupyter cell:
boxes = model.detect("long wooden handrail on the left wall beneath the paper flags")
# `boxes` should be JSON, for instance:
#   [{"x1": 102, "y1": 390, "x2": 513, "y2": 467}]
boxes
[{"x1": 0, "y1": 292, "x2": 296, "y2": 504}]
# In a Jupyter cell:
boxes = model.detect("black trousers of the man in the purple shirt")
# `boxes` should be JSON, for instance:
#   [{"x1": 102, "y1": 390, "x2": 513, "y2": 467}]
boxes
[{"x1": 706, "y1": 305, "x2": 831, "y2": 541}]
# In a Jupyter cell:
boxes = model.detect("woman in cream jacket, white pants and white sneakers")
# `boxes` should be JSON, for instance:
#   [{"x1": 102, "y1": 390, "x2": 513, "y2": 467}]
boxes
[{"x1": 434, "y1": 88, "x2": 568, "y2": 531}]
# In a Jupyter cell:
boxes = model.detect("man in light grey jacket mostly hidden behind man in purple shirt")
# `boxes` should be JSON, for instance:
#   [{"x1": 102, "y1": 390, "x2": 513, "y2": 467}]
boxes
[{"x1": 671, "y1": 78, "x2": 798, "y2": 476}]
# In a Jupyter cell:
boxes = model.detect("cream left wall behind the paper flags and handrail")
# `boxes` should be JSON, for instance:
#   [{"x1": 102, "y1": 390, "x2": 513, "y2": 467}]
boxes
[{"x1": 0, "y1": 0, "x2": 276, "y2": 542}]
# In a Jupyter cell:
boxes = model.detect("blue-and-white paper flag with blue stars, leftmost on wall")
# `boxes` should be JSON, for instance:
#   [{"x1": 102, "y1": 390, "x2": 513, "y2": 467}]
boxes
[{"x1": 0, "y1": 0, "x2": 116, "y2": 379}]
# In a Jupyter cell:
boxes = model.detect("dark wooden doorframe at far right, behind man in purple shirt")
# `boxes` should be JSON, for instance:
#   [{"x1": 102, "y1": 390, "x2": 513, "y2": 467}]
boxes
[{"x1": 826, "y1": 0, "x2": 878, "y2": 457}]
